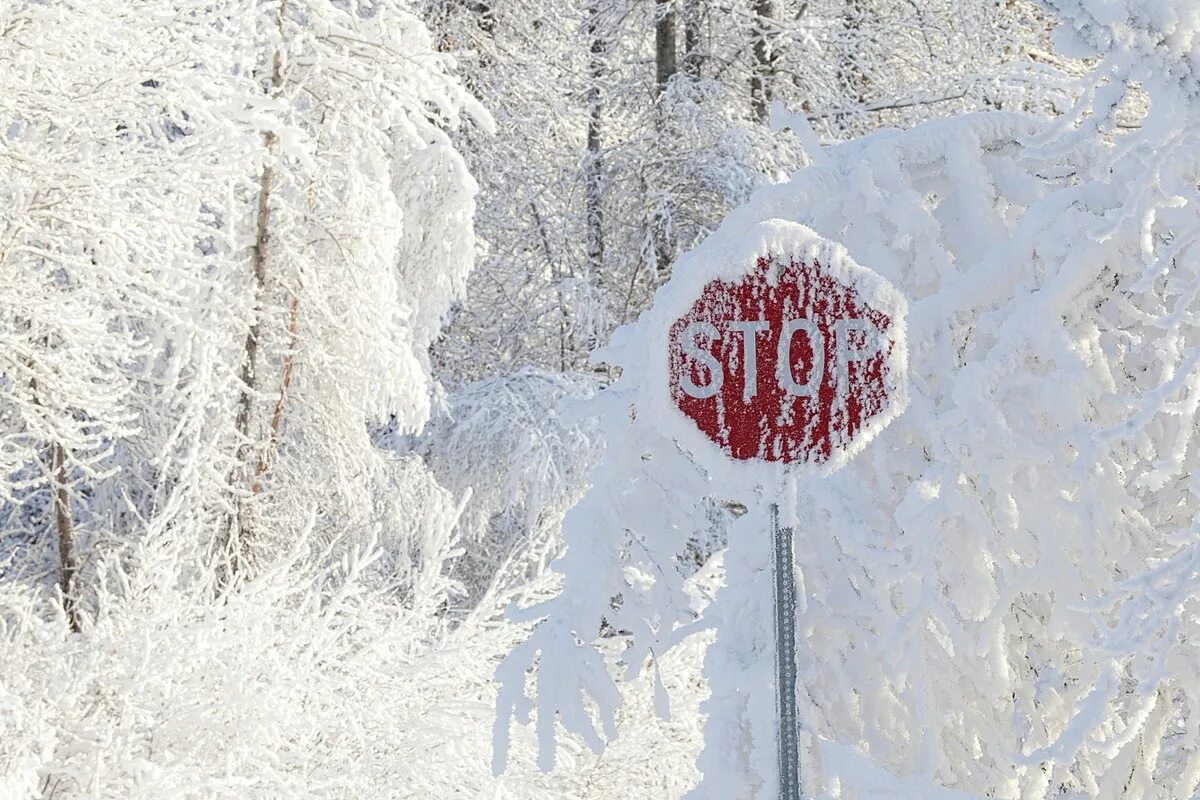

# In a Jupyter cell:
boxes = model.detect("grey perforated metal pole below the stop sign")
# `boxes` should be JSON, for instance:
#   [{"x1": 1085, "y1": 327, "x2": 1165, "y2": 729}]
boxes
[{"x1": 770, "y1": 503, "x2": 800, "y2": 800}]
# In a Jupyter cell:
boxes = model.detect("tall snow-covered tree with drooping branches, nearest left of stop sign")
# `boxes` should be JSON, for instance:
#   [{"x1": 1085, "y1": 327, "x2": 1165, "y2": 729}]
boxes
[{"x1": 216, "y1": 0, "x2": 490, "y2": 579}]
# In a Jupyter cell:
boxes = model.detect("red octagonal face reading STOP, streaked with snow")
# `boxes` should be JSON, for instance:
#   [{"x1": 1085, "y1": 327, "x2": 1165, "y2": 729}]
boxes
[{"x1": 668, "y1": 258, "x2": 895, "y2": 464}]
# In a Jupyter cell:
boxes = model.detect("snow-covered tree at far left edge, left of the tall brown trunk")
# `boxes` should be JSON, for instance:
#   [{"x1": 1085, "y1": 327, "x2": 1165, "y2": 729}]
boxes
[{"x1": 0, "y1": 2, "x2": 261, "y2": 627}]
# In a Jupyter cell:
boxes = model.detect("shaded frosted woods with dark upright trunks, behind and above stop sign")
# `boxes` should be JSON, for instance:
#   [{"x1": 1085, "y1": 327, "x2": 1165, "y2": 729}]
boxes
[{"x1": 427, "y1": 0, "x2": 1073, "y2": 384}]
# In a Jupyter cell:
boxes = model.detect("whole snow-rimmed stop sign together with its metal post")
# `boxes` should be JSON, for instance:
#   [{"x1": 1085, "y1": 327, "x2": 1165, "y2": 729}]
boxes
[{"x1": 648, "y1": 219, "x2": 907, "y2": 800}]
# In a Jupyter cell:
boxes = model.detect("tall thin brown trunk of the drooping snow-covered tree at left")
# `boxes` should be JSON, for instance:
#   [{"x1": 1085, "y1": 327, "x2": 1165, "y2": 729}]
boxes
[{"x1": 221, "y1": 0, "x2": 288, "y2": 583}]
